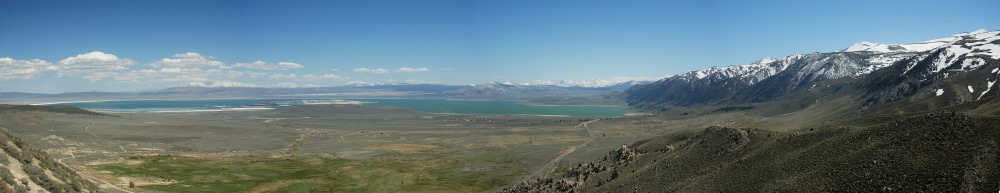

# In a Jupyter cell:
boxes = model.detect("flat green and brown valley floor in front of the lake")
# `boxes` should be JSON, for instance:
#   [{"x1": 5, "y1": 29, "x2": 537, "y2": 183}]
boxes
[{"x1": 0, "y1": 105, "x2": 700, "y2": 192}]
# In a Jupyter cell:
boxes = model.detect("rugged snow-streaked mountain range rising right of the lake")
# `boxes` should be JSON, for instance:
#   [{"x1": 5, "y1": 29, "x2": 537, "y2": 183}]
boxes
[{"x1": 622, "y1": 30, "x2": 1000, "y2": 110}]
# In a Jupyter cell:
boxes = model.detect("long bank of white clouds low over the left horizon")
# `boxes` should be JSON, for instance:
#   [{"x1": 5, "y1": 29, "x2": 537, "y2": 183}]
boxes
[{"x1": 0, "y1": 51, "x2": 356, "y2": 87}]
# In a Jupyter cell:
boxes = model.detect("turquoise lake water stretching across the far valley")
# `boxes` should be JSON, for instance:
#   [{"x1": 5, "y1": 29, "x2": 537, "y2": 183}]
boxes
[{"x1": 43, "y1": 99, "x2": 628, "y2": 117}]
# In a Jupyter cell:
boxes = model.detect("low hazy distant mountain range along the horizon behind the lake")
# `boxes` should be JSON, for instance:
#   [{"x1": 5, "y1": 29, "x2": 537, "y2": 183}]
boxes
[{"x1": 0, "y1": 79, "x2": 651, "y2": 103}]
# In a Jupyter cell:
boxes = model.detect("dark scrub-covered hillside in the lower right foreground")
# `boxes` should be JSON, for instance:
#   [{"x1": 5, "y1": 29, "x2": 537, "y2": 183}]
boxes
[{"x1": 504, "y1": 109, "x2": 1000, "y2": 192}]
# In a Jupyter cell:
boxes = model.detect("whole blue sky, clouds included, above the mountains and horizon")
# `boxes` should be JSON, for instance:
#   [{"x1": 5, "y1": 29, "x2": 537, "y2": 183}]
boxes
[{"x1": 0, "y1": 0, "x2": 1000, "y2": 93}]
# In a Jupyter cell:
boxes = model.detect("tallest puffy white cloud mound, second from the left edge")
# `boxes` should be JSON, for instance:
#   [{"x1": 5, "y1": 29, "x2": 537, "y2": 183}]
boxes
[{"x1": 54, "y1": 51, "x2": 136, "y2": 81}]
